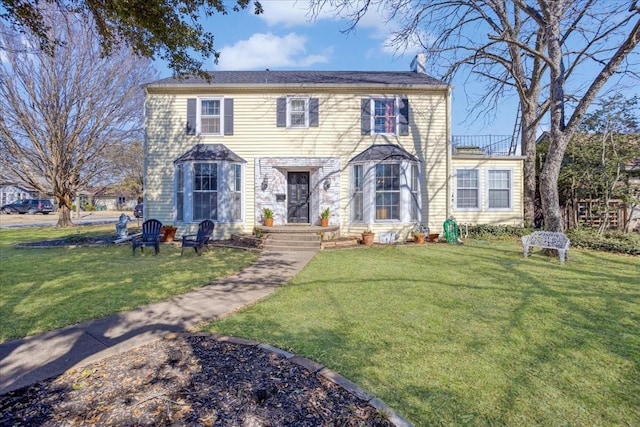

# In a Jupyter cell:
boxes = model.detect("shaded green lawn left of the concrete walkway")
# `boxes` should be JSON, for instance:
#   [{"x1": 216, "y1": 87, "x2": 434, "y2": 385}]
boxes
[{"x1": 0, "y1": 226, "x2": 256, "y2": 342}]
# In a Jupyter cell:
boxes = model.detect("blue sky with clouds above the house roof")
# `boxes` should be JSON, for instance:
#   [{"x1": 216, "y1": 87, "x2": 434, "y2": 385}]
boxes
[{"x1": 152, "y1": 0, "x2": 637, "y2": 139}]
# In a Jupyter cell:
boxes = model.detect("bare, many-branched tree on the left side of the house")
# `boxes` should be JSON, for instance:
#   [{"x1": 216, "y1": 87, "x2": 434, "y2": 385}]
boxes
[{"x1": 0, "y1": 10, "x2": 155, "y2": 226}]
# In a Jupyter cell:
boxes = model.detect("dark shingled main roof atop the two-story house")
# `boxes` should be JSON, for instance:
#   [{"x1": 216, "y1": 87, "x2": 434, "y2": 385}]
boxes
[{"x1": 147, "y1": 71, "x2": 447, "y2": 86}]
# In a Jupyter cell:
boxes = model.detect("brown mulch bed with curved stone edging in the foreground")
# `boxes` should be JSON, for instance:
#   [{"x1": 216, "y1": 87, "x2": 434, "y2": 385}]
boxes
[{"x1": 0, "y1": 335, "x2": 393, "y2": 426}]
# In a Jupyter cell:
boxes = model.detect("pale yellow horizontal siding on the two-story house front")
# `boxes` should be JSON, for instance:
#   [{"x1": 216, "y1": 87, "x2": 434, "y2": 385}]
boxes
[{"x1": 145, "y1": 90, "x2": 448, "y2": 239}]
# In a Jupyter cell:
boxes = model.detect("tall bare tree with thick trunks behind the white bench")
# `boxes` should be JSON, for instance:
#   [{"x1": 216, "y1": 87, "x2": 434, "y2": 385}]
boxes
[{"x1": 312, "y1": 0, "x2": 640, "y2": 231}]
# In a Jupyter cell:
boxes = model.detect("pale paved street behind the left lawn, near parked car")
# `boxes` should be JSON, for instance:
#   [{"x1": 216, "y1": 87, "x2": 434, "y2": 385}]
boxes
[{"x1": 0, "y1": 210, "x2": 132, "y2": 228}]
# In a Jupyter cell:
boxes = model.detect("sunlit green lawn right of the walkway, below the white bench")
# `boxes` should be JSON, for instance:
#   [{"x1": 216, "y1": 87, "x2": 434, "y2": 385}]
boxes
[{"x1": 207, "y1": 239, "x2": 640, "y2": 426}]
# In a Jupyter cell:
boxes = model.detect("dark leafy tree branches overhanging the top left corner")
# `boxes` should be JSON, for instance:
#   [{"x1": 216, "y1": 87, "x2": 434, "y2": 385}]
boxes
[{"x1": 0, "y1": 0, "x2": 262, "y2": 75}]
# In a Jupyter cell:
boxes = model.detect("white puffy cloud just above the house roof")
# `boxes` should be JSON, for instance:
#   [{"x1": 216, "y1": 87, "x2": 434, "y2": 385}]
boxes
[{"x1": 214, "y1": 33, "x2": 332, "y2": 70}]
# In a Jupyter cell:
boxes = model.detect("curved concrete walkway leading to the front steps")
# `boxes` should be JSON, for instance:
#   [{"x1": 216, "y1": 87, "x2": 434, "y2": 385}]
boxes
[{"x1": 0, "y1": 251, "x2": 316, "y2": 394}]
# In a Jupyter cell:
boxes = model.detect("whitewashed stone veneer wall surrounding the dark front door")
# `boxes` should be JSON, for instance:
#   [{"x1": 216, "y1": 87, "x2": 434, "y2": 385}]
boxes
[{"x1": 254, "y1": 157, "x2": 341, "y2": 225}]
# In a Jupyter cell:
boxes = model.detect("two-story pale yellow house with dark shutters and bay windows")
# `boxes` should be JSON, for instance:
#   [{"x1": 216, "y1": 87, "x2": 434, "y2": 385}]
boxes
[{"x1": 144, "y1": 57, "x2": 523, "y2": 241}]
